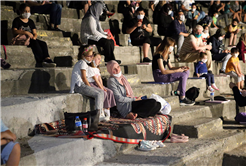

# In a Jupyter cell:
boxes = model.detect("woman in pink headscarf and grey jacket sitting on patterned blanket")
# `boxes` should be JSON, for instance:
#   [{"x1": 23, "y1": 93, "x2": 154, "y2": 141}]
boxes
[{"x1": 107, "y1": 60, "x2": 161, "y2": 119}]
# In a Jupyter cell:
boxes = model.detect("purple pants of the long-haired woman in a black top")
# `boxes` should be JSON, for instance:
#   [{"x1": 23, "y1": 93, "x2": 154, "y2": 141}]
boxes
[{"x1": 153, "y1": 69, "x2": 190, "y2": 96}]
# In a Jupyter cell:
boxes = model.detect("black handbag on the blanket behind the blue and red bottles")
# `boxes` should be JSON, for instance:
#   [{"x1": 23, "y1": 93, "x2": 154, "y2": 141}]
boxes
[{"x1": 64, "y1": 110, "x2": 100, "y2": 131}]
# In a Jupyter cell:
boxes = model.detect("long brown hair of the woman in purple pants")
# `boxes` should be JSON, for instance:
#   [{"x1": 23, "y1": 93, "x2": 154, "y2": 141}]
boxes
[{"x1": 154, "y1": 37, "x2": 175, "y2": 59}]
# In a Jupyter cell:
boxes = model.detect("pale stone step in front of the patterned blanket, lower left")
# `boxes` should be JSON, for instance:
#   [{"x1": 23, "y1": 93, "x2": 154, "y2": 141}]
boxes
[{"x1": 19, "y1": 136, "x2": 117, "y2": 166}]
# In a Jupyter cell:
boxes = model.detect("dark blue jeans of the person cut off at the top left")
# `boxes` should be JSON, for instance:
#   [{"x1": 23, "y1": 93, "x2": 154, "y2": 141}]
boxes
[{"x1": 31, "y1": 3, "x2": 62, "y2": 25}]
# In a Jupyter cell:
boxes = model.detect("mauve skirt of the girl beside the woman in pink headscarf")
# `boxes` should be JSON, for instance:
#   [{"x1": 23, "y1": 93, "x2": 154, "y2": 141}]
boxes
[{"x1": 90, "y1": 82, "x2": 116, "y2": 108}]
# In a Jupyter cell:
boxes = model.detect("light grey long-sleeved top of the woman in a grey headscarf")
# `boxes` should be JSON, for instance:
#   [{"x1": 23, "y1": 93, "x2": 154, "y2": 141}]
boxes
[{"x1": 80, "y1": 16, "x2": 107, "y2": 45}]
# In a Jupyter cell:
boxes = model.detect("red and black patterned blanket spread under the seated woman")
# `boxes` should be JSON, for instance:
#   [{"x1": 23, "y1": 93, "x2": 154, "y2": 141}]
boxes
[{"x1": 30, "y1": 115, "x2": 172, "y2": 144}]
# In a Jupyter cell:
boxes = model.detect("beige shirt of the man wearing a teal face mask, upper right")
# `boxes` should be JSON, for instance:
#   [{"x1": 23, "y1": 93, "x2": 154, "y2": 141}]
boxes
[{"x1": 180, "y1": 34, "x2": 202, "y2": 55}]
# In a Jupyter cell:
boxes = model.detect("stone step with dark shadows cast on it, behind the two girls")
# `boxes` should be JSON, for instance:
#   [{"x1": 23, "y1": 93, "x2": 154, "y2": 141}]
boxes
[{"x1": 0, "y1": 67, "x2": 141, "y2": 97}]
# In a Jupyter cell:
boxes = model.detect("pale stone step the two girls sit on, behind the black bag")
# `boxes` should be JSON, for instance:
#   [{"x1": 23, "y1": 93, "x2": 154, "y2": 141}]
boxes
[{"x1": 0, "y1": 94, "x2": 177, "y2": 138}]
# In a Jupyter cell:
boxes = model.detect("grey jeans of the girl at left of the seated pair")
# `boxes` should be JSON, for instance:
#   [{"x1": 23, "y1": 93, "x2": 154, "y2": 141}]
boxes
[{"x1": 74, "y1": 84, "x2": 104, "y2": 110}]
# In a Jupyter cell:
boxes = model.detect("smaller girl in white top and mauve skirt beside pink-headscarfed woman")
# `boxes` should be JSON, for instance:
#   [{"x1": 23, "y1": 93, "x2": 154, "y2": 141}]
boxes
[{"x1": 88, "y1": 53, "x2": 116, "y2": 121}]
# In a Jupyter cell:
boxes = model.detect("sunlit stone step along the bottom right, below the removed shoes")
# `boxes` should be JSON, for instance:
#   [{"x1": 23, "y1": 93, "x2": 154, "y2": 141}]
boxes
[{"x1": 96, "y1": 131, "x2": 246, "y2": 166}]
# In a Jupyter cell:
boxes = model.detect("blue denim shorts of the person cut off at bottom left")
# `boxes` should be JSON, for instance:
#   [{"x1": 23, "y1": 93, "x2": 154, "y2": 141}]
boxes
[{"x1": 0, "y1": 141, "x2": 18, "y2": 165}]
